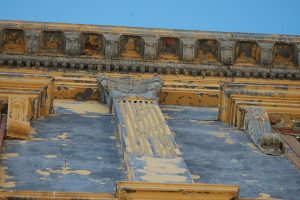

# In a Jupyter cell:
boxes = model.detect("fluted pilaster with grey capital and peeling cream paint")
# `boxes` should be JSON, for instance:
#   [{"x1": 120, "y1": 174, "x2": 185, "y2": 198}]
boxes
[{"x1": 97, "y1": 76, "x2": 193, "y2": 183}]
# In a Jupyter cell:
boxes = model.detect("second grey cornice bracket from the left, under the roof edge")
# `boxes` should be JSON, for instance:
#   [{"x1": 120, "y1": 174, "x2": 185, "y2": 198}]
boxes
[{"x1": 65, "y1": 32, "x2": 81, "y2": 56}]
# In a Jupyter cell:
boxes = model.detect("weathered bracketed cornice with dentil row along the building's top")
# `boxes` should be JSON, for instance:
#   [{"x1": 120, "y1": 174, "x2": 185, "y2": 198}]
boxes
[{"x1": 0, "y1": 21, "x2": 300, "y2": 79}]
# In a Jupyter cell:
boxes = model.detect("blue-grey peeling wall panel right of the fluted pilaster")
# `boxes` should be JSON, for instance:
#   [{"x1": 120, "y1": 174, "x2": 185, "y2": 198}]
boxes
[{"x1": 162, "y1": 106, "x2": 300, "y2": 200}]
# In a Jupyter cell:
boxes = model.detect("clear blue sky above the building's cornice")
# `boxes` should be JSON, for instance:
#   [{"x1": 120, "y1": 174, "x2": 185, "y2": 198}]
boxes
[{"x1": 0, "y1": 0, "x2": 300, "y2": 35}]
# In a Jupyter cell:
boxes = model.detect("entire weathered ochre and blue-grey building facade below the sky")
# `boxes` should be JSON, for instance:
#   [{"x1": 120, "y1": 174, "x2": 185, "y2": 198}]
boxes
[{"x1": 0, "y1": 21, "x2": 300, "y2": 199}]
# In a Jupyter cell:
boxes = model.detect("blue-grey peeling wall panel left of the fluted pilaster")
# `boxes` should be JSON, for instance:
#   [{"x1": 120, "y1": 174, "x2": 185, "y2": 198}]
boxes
[{"x1": 0, "y1": 102, "x2": 126, "y2": 193}]
